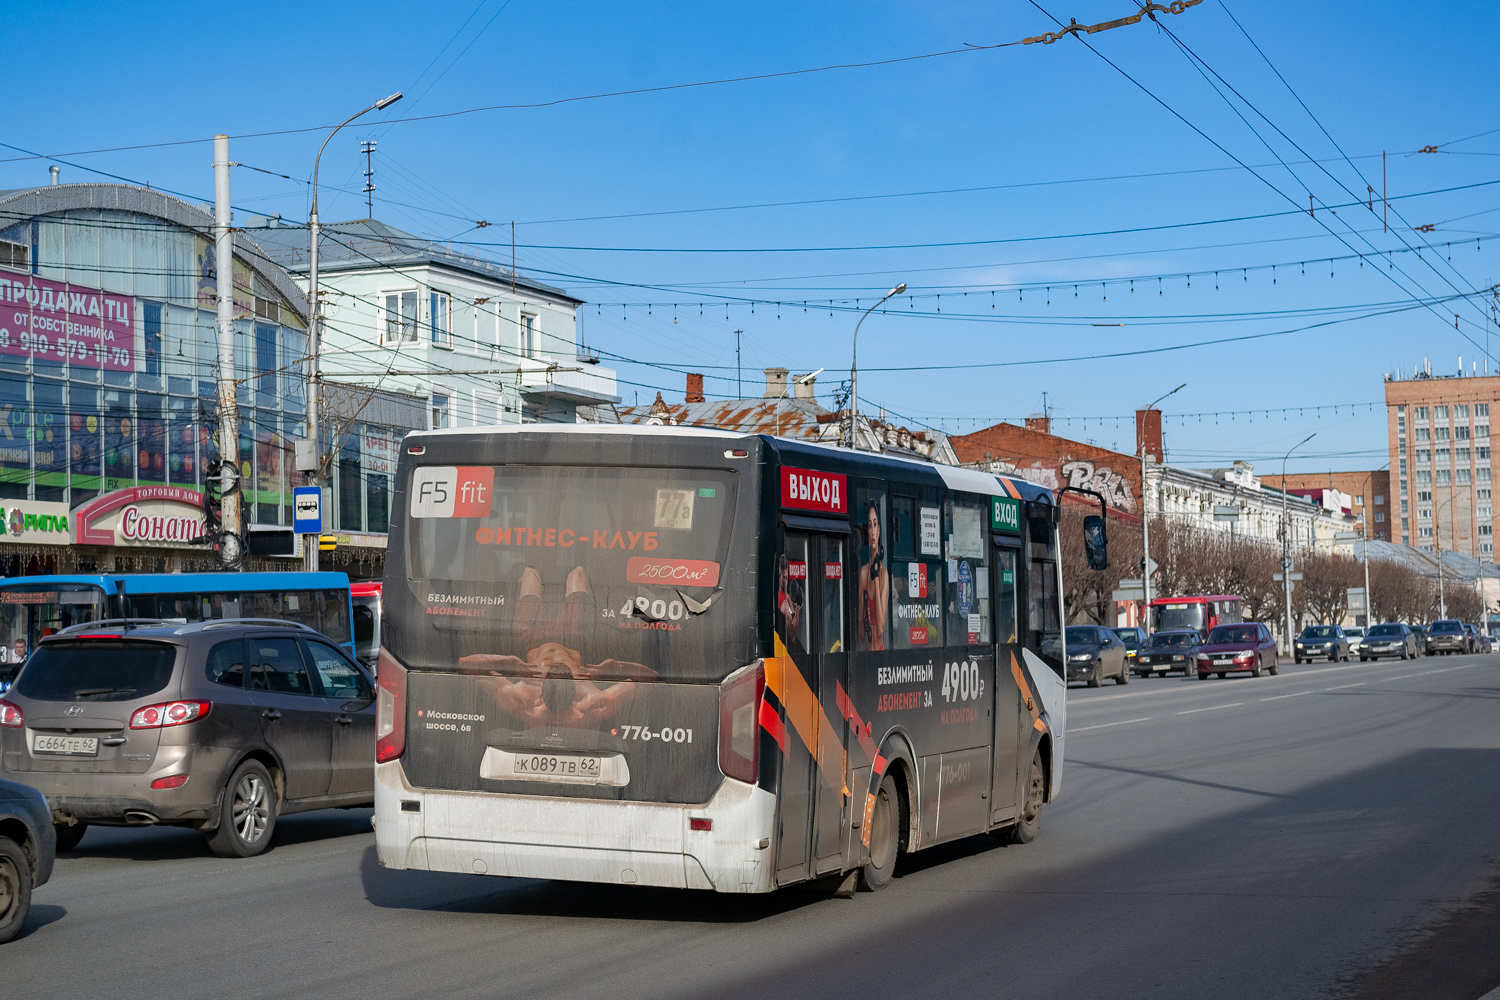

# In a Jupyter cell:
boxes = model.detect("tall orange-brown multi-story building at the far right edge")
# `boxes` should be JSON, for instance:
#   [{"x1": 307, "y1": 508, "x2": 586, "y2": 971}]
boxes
[{"x1": 1386, "y1": 372, "x2": 1500, "y2": 561}]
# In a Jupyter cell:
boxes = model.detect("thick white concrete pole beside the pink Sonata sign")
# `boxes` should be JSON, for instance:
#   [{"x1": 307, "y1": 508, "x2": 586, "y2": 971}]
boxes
[{"x1": 214, "y1": 135, "x2": 245, "y2": 565}]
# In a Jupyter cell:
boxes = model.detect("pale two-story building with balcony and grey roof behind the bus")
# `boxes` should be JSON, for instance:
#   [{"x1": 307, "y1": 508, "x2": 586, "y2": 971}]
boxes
[{"x1": 245, "y1": 216, "x2": 620, "y2": 427}]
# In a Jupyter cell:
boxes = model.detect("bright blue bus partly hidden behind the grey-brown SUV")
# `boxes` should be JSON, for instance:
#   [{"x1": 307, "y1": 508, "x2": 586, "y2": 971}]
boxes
[{"x1": 0, "y1": 573, "x2": 354, "y2": 679}]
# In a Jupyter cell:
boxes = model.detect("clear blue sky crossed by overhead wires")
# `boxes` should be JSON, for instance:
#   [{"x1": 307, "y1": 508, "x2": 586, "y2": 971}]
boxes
[{"x1": 0, "y1": 0, "x2": 1500, "y2": 471}]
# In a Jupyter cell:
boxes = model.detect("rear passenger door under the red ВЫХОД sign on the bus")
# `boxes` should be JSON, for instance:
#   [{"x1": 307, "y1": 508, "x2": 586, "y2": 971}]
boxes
[{"x1": 776, "y1": 531, "x2": 849, "y2": 883}]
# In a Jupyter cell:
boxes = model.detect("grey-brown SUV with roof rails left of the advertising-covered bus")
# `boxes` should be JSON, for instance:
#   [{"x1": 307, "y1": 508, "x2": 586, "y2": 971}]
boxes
[{"x1": 0, "y1": 619, "x2": 375, "y2": 858}]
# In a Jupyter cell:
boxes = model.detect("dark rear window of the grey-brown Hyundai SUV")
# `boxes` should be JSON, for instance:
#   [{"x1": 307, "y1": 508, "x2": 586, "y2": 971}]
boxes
[{"x1": 15, "y1": 639, "x2": 177, "y2": 702}]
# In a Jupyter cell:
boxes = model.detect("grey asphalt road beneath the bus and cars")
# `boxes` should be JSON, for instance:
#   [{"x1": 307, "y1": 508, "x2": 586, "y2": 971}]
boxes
[{"x1": 0, "y1": 655, "x2": 1500, "y2": 1000}]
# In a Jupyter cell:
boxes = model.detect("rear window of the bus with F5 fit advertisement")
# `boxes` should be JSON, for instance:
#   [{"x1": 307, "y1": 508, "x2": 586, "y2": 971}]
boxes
[{"x1": 405, "y1": 466, "x2": 749, "y2": 678}]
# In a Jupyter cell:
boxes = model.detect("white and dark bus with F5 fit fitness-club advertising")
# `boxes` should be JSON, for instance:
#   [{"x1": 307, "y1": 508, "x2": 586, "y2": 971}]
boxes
[{"x1": 375, "y1": 426, "x2": 1067, "y2": 892}]
